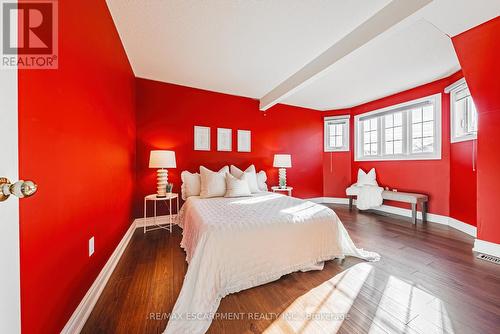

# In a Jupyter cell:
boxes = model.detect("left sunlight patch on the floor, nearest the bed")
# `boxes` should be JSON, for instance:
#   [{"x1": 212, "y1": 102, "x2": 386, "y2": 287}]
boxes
[{"x1": 264, "y1": 263, "x2": 373, "y2": 334}]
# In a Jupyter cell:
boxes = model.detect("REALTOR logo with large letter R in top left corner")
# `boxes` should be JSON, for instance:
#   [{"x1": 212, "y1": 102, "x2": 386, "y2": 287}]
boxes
[{"x1": 1, "y1": 0, "x2": 58, "y2": 69}]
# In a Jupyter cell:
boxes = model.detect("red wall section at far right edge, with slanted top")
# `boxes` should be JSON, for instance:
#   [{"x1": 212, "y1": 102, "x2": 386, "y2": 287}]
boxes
[{"x1": 452, "y1": 17, "x2": 500, "y2": 243}]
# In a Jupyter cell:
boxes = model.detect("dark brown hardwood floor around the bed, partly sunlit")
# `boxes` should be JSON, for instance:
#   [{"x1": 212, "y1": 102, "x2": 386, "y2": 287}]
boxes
[{"x1": 82, "y1": 205, "x2": 500, "y2": 334}]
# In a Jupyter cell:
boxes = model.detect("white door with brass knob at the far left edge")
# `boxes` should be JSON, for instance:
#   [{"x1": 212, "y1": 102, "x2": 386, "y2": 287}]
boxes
[{"x1": 0, "y1": 18, "x2": 21, "y2": 334}]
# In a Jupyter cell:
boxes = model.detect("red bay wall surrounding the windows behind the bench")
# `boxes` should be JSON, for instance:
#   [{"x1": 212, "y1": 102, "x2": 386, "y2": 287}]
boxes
[{"x1": 324, "y1": 72, "x2": 476, "y2": 225}]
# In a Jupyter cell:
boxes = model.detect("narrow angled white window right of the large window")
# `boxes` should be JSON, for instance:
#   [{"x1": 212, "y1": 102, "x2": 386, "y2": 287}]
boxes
[{"x1": 445, "y1": 79, "x2": 477, "y2": 143}]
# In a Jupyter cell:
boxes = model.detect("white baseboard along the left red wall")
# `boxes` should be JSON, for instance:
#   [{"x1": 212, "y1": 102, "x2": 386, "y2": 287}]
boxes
[{"x1": 61, "y1": 222, "x2": 136, "y2": 334}]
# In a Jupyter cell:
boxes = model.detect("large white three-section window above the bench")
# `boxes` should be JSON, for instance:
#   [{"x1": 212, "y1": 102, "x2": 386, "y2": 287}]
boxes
[{"x1": 354, "y1": 94, "x2": 441, "y2": 161}]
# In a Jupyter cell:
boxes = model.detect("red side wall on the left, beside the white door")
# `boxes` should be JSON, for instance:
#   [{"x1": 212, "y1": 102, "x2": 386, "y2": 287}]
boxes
[{"x1": 19, "y1": 0, "x2": 135, "y2": 334}]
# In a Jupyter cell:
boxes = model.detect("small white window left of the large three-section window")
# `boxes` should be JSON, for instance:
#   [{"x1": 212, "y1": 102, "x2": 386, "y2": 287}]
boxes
[{"x1": 325, "y1": 115, "x2": 350, "y2": 152}]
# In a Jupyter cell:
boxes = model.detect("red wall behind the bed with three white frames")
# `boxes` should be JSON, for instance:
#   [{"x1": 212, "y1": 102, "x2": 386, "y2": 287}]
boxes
[{"x1": 135, "y1": 79, "x2": 323, "y2": 216}]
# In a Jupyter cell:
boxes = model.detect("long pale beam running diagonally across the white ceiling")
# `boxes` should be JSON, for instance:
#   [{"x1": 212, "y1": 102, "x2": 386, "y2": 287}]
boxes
[{"x1": 259, "y1": 0, "x2": 433, "y2": 111}]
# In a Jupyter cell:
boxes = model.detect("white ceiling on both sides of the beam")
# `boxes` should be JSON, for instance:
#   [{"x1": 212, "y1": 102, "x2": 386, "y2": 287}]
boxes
[{"x1": 107, "y1": 0, "x2": 500, "y2": 110}]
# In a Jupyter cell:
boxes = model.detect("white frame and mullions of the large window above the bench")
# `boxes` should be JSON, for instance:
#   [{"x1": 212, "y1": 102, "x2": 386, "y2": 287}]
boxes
[{"x1": 354, "y1": 93, "x2": 442, "y2": 161}]
